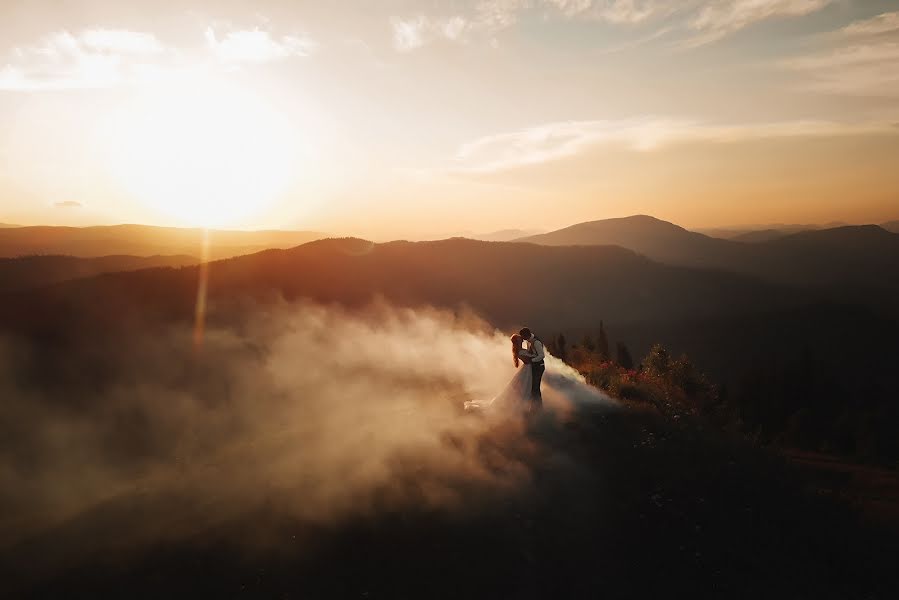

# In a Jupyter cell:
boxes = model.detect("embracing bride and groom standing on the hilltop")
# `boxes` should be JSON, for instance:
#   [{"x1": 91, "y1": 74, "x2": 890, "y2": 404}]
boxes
[{"x1": 465, "y1": 327, "x2": 546, "y2": 413}]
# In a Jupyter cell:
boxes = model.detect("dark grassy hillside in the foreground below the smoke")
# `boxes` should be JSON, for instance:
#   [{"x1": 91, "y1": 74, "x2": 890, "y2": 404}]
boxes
[{"x1": 3, "y1": 398, "x2": 899, "y2": 598}]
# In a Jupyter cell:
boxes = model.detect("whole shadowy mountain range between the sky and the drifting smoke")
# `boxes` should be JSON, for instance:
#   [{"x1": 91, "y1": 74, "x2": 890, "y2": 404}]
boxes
[{"x1": 0, "y1": 217, "x2": 899, "y2": 488}]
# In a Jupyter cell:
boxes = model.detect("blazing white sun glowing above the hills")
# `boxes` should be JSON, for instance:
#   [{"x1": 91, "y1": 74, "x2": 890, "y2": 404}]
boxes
[{"x1": 112, "y1": 83, "x2": 297, "y2": 227}]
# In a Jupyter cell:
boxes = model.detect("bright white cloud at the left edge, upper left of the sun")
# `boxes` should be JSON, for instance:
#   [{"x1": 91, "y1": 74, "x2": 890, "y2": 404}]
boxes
[{"x1": 0, "y1": 29, "x2": 167, "y2": 91}]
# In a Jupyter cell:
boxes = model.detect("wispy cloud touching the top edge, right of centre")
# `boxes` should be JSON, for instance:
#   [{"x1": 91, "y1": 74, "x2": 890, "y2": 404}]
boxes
[{"x1": 685, "y1": 0, "x2": 833, "y2": 47}]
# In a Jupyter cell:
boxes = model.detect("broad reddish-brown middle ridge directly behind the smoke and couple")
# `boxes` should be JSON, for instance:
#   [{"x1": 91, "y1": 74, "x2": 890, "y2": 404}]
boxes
[{"x1": 0, "y1": 239, "x2": 895, "y2": 394}]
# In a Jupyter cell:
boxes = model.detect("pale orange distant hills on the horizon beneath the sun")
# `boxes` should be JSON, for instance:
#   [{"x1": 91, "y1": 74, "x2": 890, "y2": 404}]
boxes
[{"x1": 0, "y1": 225, "x2": 324, "y2": 258}]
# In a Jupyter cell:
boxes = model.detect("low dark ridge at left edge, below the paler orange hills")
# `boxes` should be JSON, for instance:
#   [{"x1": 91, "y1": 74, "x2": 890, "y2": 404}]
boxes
[{"x1": 0, "y1": 255, "x2": 200, "y2": 292}]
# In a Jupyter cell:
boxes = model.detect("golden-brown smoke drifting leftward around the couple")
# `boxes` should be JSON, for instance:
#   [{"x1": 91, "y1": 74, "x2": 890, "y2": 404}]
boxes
[{"x1": 0, "y1": 302, "x2": 615, "y2": 551}]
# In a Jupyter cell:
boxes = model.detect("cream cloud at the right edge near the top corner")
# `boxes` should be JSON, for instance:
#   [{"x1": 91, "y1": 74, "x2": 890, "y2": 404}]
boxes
[{"x1": 780, "y1": 12, "x2": 899, "y2": 98}]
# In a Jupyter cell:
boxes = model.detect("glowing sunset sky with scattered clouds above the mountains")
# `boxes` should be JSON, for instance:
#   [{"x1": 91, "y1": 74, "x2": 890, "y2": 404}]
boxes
[{"x1": 0, "y1": 0, "x2": 899, "y2": 239}]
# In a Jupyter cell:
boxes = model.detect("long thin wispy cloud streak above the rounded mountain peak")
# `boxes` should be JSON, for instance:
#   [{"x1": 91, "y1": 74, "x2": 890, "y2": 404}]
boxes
[{"x1": 452, "y1": 117, "x2": 890, "y2": 172}]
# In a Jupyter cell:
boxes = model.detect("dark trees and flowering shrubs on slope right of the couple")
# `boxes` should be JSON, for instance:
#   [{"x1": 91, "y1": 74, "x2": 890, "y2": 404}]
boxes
[{"x1": 546, "y1": 321, "x2": 899, "y2": 465}]
